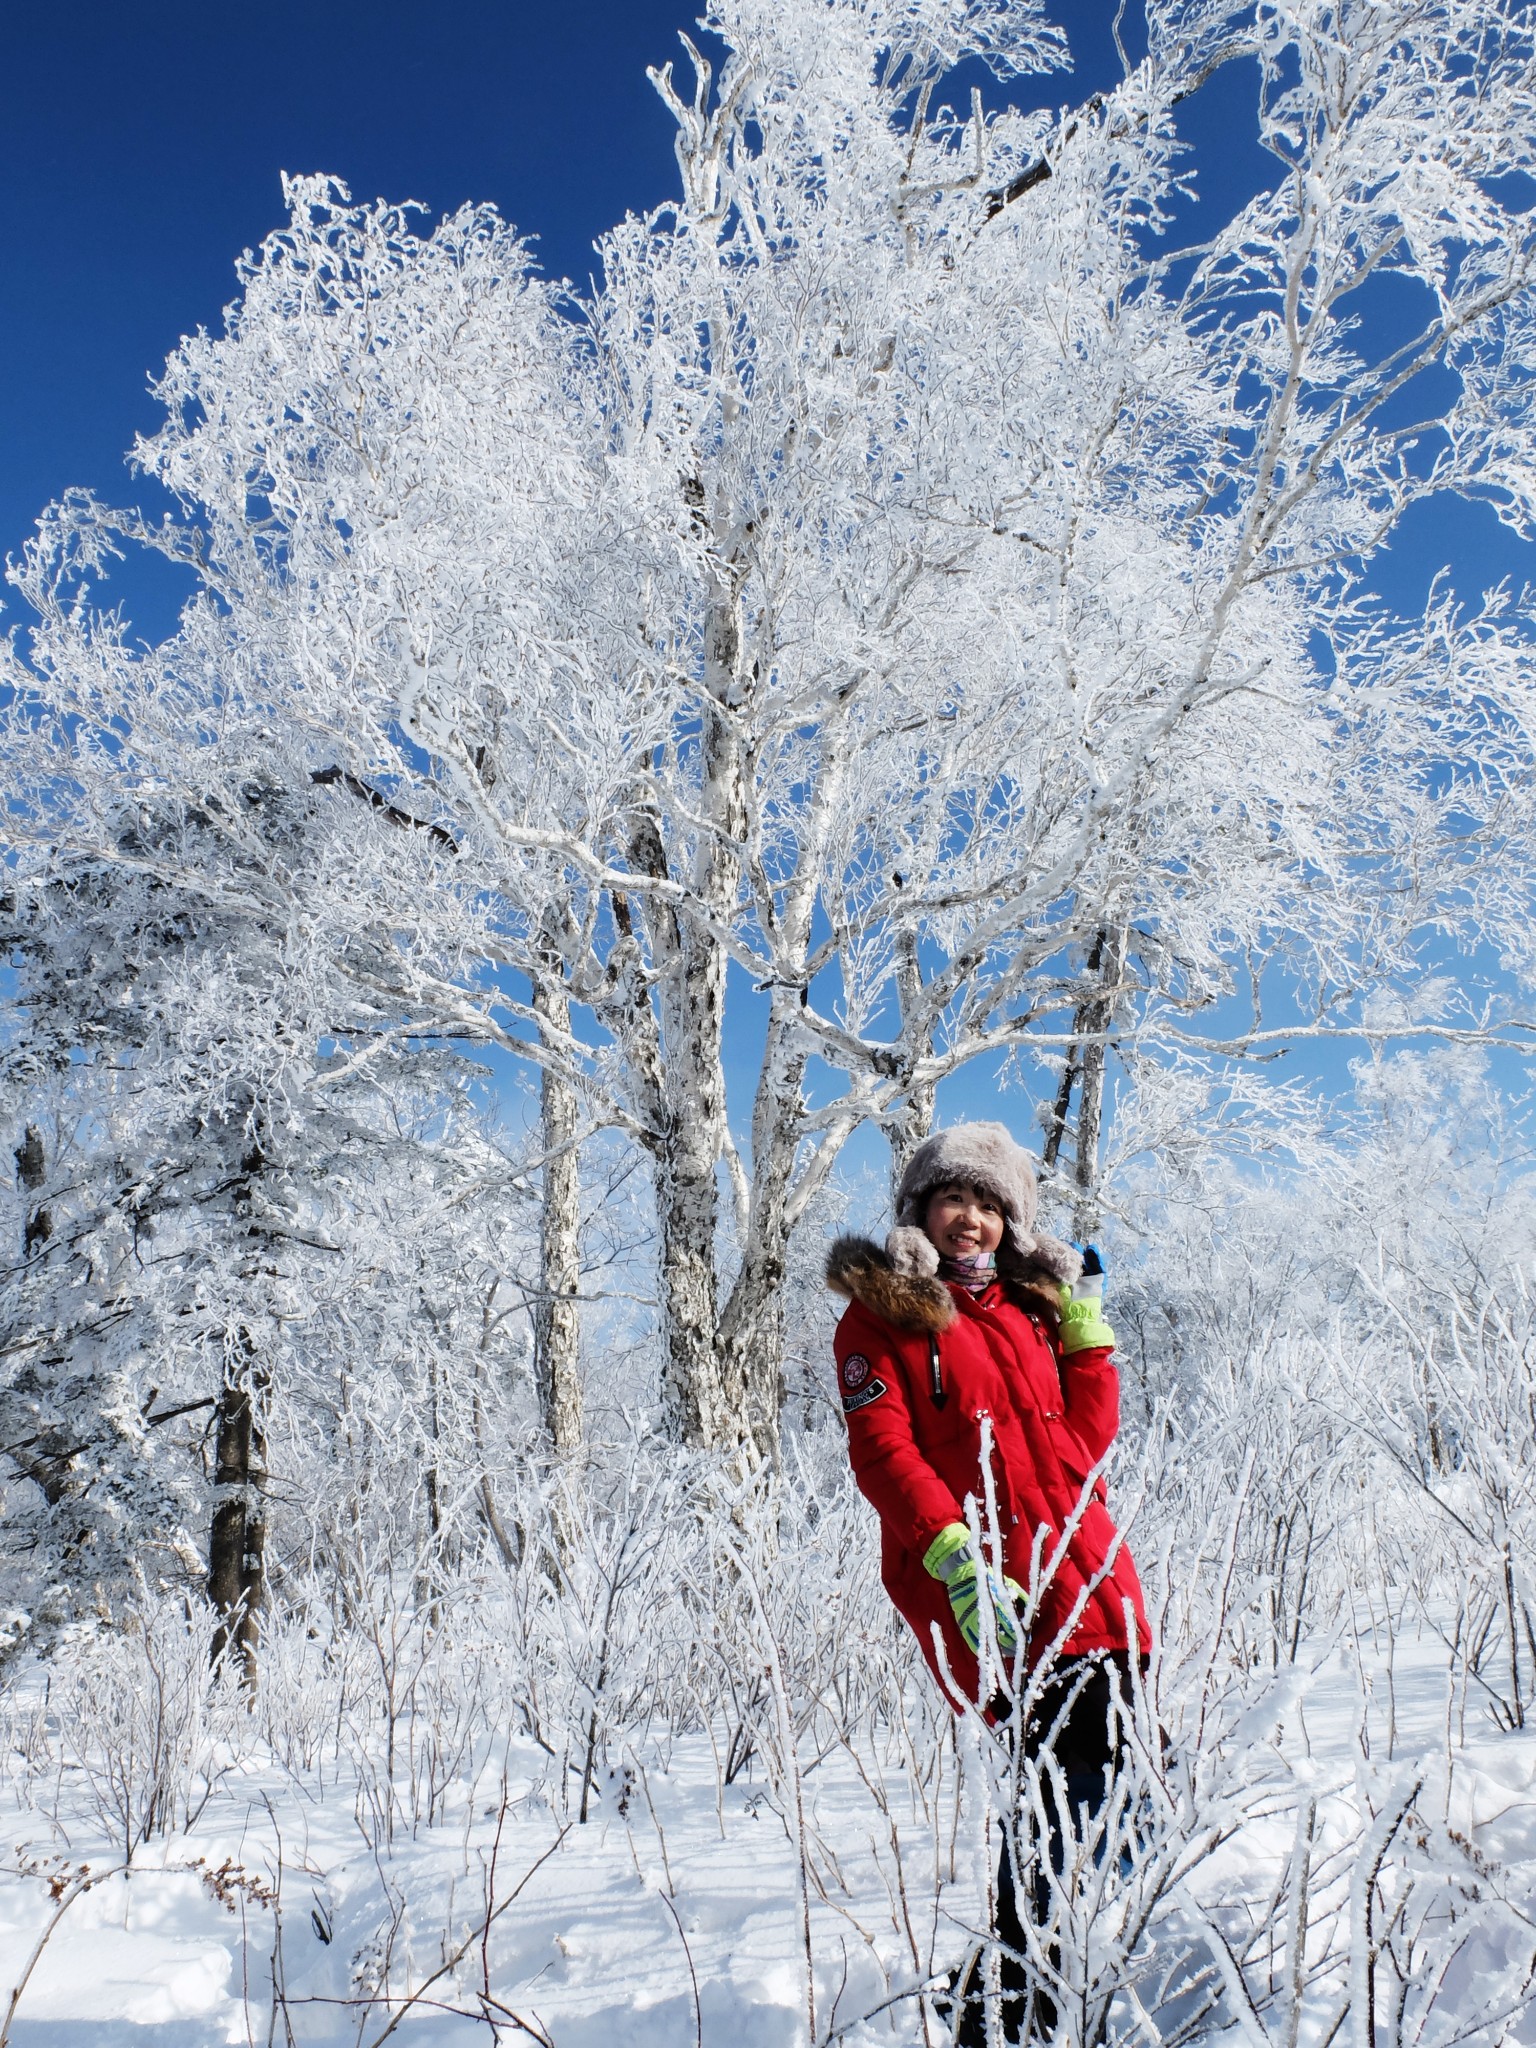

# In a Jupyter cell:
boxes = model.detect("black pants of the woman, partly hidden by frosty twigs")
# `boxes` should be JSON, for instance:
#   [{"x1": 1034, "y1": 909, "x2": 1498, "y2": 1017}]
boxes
[{"x1": 954, "y1": 1653, "x2": 1130, "y2": 2048}]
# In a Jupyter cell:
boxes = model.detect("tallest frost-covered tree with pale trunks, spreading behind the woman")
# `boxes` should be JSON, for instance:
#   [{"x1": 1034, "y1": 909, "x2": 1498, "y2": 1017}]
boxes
[{"x1": 6, "y1": 0, "x2": 1536, "y2": 1446}]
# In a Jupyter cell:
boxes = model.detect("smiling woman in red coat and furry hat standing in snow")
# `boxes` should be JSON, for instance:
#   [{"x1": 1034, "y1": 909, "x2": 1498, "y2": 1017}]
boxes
[{"x1": 827, "y1": 1122, "x2": 1149, "y2": 2042}]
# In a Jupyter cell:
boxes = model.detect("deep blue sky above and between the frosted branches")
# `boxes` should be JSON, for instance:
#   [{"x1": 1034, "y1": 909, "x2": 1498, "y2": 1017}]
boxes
[{"x1": 0, "y1": 0, "x2": 1532, "y2": 1196}]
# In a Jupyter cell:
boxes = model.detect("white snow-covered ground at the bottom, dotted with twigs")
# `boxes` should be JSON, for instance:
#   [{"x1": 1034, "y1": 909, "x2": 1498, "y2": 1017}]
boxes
[{"x1": 0, "y1": 1613, "x2": 1536, "y2": 2048}]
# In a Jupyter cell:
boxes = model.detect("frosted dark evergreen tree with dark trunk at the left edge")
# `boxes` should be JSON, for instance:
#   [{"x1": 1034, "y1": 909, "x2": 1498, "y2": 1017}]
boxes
[{"x1": 0, "y1": 782, "x2": 530, "y2": 1667}]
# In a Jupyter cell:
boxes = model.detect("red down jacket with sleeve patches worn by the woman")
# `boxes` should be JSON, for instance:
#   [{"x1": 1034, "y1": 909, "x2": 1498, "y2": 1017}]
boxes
[{"x1": 827, "y1": 1237, "x2": 1151, "y2": 1698}]
